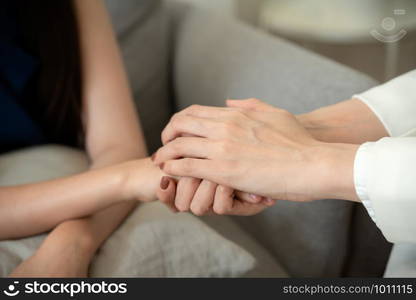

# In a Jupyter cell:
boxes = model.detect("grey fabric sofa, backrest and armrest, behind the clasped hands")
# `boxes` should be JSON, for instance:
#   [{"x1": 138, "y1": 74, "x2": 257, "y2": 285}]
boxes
[{"x1": 107, "y1": 0, "x2": 391, "y2": 277}]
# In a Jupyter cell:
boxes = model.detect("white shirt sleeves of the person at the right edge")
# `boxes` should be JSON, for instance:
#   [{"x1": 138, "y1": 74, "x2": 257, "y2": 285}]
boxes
[{"x1": 354, "y1": 70, "x2": 416, "y2": 242}]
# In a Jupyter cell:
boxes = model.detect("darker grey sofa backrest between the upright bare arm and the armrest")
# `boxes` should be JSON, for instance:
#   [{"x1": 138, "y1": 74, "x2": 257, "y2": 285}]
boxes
[{"x1": 106, "y1": 0, "x2": 172, "y2": 152}]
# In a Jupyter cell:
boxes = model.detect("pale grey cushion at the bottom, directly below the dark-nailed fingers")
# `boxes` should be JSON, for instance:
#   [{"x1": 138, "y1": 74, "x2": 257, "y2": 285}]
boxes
[{"x1": 90, "y1": 202, "x2": 255, "y2": 277}]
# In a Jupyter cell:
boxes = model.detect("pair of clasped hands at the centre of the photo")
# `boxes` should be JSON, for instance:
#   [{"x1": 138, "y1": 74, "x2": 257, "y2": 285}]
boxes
[{"x1": 152, "y1": 99, "x2": 360, "y2": 216}]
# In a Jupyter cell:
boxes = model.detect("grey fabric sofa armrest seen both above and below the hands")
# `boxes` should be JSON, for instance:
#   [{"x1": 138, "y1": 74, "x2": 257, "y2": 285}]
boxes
[{"x1": 173, "y1": 9, "x2": 389, "y2": 277}]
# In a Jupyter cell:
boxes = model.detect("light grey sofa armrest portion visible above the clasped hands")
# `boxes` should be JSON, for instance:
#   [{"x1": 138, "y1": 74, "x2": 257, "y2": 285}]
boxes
[{"x1": 173, "y1": 8, "x2": 376, "y2": 113}]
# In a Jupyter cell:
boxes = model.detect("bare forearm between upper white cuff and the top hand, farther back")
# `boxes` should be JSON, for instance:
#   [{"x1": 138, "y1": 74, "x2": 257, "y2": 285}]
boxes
[{"x1": 297, "y1": 99, "x2": 388, "y2": 144}]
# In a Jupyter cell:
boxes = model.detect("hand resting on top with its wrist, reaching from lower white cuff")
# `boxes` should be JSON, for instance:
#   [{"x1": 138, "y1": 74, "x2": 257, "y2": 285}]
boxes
[{"x1": 154, "y1": 99, "x2": 358, "y2": 201}]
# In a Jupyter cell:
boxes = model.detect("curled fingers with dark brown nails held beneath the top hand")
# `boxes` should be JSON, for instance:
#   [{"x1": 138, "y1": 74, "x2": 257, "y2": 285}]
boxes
[{"x1": 157, "y1": 176, "x2": 275, "y2": 216}]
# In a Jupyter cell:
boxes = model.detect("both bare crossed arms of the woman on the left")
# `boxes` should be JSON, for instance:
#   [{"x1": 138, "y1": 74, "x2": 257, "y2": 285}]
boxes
[{"x1": 5, "y1": 0, "x2": 264, "y2": 277}]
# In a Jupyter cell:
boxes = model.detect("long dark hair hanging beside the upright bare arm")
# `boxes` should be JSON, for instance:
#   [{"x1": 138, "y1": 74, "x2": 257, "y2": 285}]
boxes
[{"x1": 15, "y1": 0, "x2": 84, "y2": 146}]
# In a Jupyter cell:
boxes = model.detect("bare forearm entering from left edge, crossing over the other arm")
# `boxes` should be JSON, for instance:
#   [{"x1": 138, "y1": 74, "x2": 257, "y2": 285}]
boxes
[{"x1": 0, "y1": 164, "x2": 128, "y2": 239}]
